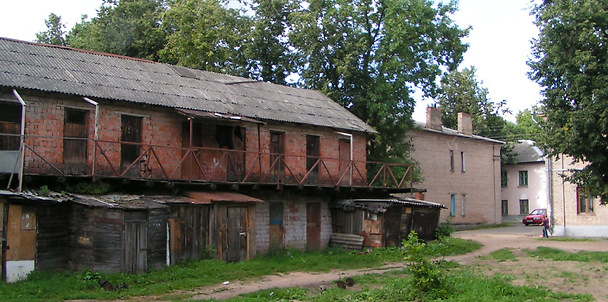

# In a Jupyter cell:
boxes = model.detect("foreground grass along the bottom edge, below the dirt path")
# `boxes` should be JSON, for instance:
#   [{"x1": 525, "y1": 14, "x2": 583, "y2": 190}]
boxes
[{"x1": 221, "y1": 270, "x2": 593, "y2": 302}]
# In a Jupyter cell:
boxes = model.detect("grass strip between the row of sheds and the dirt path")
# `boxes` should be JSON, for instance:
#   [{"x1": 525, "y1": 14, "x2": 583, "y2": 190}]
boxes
[{"x1": 0, "y1": 238, "x2": 475, "y2": 301}]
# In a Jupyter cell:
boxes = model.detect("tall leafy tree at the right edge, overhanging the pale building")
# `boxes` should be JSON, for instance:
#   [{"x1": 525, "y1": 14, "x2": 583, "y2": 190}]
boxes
[{"x1": 528, "y1": 0, "x2": 608, "y2": 201}]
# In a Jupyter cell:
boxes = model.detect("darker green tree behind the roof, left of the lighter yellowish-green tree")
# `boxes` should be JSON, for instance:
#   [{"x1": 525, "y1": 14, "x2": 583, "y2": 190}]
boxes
[{"x1": 67, "y1": 0, "x2": 166, "y2": 61}]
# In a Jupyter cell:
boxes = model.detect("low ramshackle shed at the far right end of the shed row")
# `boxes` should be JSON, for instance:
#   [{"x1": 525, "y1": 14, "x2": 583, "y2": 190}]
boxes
[{"x1": 331, "y1": 197, "x2": 445, "y2": 247}]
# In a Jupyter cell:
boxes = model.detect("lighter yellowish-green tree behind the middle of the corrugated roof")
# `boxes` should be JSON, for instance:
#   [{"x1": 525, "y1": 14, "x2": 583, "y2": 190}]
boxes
[{"x1": 160, "y1": 0, "x2": 250, "y2": 75}]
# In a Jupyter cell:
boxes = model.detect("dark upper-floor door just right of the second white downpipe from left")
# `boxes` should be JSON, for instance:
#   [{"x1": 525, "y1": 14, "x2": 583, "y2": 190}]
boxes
[{"x1": 120, "y1": 114, "x2": 143, "y2": 176}]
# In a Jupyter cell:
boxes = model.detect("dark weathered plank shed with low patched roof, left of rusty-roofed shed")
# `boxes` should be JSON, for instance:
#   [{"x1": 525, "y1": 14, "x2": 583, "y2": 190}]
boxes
[{"x1": 69, "y1": 195, "x2": 169, "y2": 273}]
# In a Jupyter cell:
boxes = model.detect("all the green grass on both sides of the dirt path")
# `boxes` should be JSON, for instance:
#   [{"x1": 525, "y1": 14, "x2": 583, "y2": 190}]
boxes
[{"x1": 0, "y1": 238, "x2": 608, "y2": 301}]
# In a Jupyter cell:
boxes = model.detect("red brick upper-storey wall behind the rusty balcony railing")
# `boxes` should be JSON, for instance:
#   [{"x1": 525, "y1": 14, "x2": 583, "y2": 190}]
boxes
[{"x1": 7, "y1": 90, "x2": 366, "y2": 184}]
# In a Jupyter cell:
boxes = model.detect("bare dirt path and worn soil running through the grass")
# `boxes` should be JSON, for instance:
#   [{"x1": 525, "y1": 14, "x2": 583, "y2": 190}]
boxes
[{"x1": 137, "y1": 225, "x2": 608, "y2": 301}]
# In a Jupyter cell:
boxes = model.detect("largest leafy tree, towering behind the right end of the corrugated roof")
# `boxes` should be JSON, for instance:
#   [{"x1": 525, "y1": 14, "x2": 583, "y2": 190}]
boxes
[{"x1": 290, "y1": 0, "x2": 468, "y2": 160}]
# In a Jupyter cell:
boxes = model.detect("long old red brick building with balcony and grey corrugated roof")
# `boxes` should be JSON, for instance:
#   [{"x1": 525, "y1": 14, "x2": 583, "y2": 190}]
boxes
[{"x1": 0, "y1": 39, "x2": 411, "y2": 282}]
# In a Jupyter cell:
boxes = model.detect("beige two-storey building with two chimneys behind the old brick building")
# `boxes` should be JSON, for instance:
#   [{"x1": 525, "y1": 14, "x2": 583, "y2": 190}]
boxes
[{"x1": 408, "y1": 108, "x2": 504, "y2": 226}]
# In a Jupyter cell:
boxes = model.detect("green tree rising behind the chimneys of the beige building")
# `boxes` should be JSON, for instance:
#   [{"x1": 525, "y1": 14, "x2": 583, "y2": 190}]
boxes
[{"x1": 436, "y1": 66, "x2": 509, "y2": 139}]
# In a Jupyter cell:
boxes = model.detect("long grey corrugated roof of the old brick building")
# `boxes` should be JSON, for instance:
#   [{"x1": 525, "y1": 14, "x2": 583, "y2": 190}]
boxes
[{"x1": 0, "y1": 38, "x2": 376, "y2": 133}]
